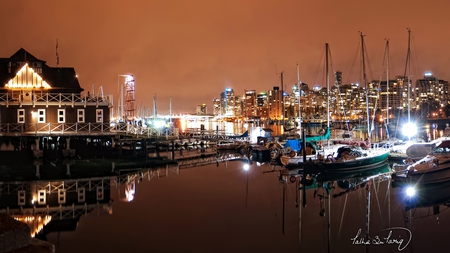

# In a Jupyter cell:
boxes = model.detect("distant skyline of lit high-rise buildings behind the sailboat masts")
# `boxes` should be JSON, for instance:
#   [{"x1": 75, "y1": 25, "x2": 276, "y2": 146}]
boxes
[{"x1": 214, "y1": 71, "x2": 449, "y2": 128}]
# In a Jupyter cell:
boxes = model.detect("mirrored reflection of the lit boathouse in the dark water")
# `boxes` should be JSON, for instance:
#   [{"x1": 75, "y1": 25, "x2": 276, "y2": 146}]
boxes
[{"x1": 0, "y1": 162, "x2": 179, "y2": 240}]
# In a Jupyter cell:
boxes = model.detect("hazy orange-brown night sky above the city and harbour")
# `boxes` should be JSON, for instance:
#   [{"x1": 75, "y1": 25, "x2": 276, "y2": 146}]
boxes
[{"x1": 0, "y1": 0, "x2": 450, "y2": 114}]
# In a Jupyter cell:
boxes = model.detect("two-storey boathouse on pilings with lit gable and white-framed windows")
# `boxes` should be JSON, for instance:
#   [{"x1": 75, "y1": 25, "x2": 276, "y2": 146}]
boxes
[{"x1": 0, "y1": 48, "x2": 115, "y2": 157}]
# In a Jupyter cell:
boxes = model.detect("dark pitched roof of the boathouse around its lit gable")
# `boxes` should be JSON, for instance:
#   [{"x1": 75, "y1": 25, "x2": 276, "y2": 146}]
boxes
[{"x1": 0, "y1": 48, "x2": 84, "y2": 93}]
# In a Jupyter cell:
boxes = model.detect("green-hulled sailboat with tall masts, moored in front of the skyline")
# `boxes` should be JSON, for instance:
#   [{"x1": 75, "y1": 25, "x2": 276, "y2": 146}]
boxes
[{"x1": 281, "y1": 34, "x2": 389, "y2": 174}]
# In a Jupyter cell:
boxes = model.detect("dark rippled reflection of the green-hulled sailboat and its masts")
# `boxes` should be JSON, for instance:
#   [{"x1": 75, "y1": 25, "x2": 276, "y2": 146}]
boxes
[{"x1": 286, "y1": 163, "x2": 392, "y2": 252}]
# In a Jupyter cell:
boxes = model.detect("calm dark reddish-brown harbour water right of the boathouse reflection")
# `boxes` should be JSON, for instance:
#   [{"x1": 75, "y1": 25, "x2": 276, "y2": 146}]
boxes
[{"x1": 41, "y1": 161, "x2": 450, "y2": 253}]
